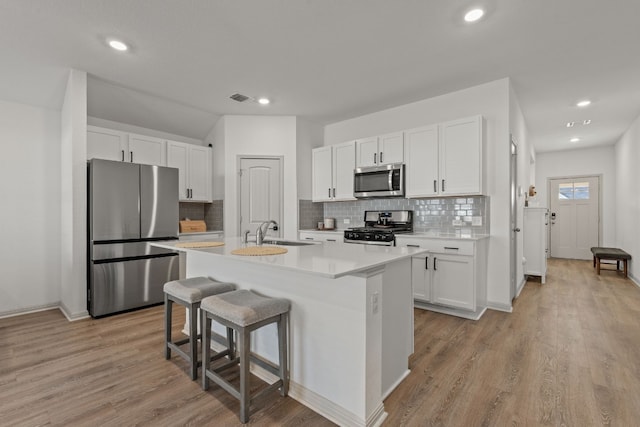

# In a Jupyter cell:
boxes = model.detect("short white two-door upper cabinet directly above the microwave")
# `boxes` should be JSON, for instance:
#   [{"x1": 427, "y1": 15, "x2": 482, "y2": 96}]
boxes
[{"x1": 356, "y1": 132, "x2": 404, "y2": 167}]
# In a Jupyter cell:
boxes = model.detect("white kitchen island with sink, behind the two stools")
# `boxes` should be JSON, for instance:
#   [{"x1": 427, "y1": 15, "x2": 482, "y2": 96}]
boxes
[{"x1": 156, "y1": 238, "x2": 421, "y2": 426}]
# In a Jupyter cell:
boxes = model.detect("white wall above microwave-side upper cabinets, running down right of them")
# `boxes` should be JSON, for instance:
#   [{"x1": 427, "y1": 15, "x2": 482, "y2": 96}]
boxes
[{"x1": 324, "y1": 79, "x2": 511, "y2": 310}]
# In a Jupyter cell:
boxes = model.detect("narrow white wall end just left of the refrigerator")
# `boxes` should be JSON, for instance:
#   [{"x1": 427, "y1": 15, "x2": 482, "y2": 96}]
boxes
[{"x1": 59, "y1": 70, "x2": 88, "y2": 320}]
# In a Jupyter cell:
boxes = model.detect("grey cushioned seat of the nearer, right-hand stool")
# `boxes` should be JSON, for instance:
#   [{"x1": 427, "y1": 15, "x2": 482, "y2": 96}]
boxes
[{"x1": 200, "y1": 289, "x2": 291, "y2": 326}]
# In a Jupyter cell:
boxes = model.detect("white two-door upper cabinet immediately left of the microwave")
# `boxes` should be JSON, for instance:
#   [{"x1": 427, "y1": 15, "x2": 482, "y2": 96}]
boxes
[{"x1": 311, "y1": 141, "x2": 355, "y2": 202}]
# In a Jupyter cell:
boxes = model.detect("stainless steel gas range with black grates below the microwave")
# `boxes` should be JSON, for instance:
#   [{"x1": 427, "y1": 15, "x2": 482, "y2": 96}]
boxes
[{"x1": 344, "y1": 211, "x2": 413, "y2": 246}]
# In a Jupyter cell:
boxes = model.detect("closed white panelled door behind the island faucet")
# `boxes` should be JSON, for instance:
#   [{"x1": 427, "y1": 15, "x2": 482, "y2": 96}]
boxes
[{"x1": 239, "y1": 158, "x2": 282, "y2": 237}]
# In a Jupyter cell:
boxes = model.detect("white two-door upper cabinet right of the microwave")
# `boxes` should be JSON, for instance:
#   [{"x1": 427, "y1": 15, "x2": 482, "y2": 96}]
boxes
[{"x1": 405, "y1": 116, "x2": 484, "y2": 197}]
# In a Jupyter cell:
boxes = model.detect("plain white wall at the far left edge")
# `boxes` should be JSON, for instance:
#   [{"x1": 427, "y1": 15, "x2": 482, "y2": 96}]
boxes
[{"x1": 0, "y1": 101, "x2": 60, "y2": 316}]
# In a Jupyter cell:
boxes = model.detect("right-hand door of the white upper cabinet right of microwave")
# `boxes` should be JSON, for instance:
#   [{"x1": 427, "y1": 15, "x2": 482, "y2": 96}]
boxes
[{"x1": 440, "y1": 116, "x2": 484, "y2": 196}]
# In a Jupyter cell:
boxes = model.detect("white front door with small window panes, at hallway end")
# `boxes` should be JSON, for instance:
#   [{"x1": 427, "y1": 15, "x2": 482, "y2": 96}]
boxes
[{"x1": 549, "y1": 176, "x2": 600, "y2": 259}]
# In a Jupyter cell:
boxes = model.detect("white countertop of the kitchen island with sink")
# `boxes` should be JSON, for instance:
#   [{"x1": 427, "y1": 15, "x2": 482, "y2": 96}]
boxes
[{"x1": 153, "y1": 237, "x2": 424, "y2": 279}]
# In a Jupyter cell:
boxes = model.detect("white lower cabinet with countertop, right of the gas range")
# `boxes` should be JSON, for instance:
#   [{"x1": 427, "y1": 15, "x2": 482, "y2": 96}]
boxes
[{"x1": 396, "y1": 237, "x2": 488, "y2": 319}]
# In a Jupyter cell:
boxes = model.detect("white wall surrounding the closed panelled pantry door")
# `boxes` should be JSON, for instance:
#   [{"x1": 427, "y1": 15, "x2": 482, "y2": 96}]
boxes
[{"x1": 213, "y1": 116, "x2": 298, "y2": 239}]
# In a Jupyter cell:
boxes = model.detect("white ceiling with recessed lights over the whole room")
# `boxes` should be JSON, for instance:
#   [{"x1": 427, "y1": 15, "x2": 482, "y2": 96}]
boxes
[{"x1": 0, "y1": 0, "x2": 640, "y2": 152}]
